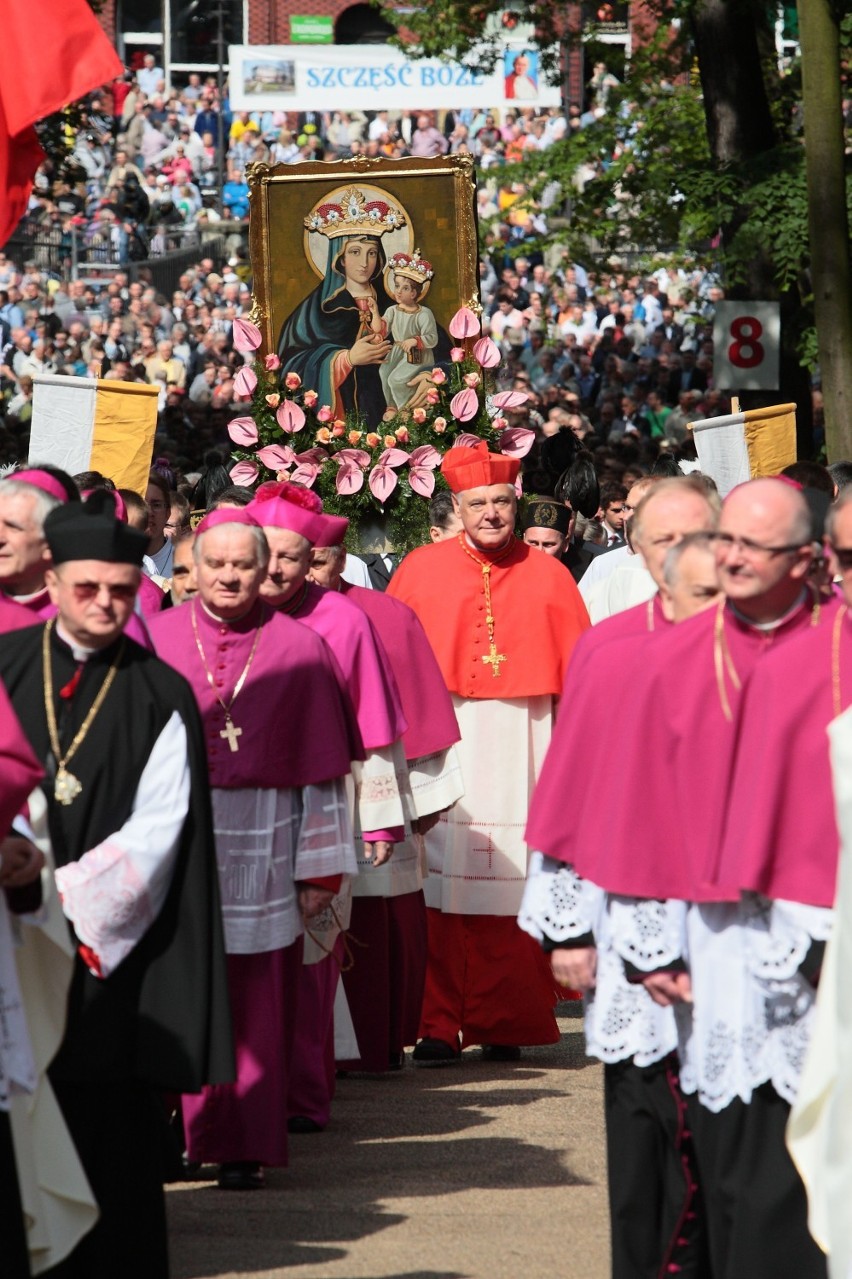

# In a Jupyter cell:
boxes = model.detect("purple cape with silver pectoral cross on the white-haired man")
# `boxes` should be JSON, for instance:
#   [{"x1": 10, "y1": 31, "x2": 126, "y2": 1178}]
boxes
[{"x1": 151, "y1": 599, "x2": 363, "y2": 789}]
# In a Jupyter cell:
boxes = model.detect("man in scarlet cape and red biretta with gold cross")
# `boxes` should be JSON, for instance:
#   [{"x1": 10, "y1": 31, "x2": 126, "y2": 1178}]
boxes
[{"x1": 388, "y1": 441, "x2": 588, "y2": 1064}]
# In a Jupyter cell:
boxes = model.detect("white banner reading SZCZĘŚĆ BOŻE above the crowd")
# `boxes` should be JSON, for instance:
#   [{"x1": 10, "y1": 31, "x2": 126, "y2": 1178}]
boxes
[{"x1": 229, "y1": 45, "x2": 559, "y2": 111}]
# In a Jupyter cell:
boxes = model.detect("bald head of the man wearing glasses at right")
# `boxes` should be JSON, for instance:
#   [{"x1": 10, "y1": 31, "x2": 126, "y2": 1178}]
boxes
[{"x1": 716, "y1": 480, "x2": 814, "y2": 623}]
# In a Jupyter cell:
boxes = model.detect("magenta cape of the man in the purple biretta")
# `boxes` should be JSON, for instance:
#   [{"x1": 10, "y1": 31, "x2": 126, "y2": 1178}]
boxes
[{"x1": 281, "y1": 582, "x2": 408, "y2": 751}]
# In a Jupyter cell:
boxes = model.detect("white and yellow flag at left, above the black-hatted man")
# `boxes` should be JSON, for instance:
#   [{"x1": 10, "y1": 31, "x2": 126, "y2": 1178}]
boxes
[{"x1": 29, "y1": 373, "x2": 159, "y2": 496}]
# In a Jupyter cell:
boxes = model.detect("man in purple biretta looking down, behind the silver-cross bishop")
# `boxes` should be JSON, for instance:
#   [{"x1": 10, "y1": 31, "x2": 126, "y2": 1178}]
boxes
[{"x1": 241, "y1": 482, "x2": 414, "y2": 1132}]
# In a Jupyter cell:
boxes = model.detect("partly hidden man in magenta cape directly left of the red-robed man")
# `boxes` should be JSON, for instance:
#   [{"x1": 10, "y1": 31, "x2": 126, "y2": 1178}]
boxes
[{"x1": 311, "y1": 517, "x2": 464, "y2": 1073}]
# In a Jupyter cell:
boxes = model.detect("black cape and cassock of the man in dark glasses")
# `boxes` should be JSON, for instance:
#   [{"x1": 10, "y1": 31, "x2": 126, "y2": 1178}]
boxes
[{"x1": 0, "y1": 625, "x2": 234, "y2": 1279}]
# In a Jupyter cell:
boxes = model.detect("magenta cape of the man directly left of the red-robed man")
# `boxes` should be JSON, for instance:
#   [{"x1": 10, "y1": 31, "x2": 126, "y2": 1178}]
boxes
[{"x1": 343, "y1": 582, "x2": 462, "y2": 760}]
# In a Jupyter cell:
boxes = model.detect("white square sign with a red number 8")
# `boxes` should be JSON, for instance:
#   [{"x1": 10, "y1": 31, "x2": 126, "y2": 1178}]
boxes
[{"x1": 713, "y1": 302, "x2": 780, "y2": 391}]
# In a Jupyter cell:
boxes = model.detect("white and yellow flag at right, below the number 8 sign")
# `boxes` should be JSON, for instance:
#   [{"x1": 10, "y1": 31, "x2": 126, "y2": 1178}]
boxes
[{"x1": 691, "y1": 404, "x2": 796, "y2": 498}]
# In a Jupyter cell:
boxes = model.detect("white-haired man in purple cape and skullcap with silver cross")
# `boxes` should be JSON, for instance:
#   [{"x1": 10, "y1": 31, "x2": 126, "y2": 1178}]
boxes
[{"x1": 154, "y1": 509, "x2": 362, "y2": 1188}]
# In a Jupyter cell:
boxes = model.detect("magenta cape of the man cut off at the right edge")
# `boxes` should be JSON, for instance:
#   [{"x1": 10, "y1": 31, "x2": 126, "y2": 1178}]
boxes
[{"x1": 710, "y1": 601, "x2": 852, "y2": 907}]
